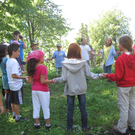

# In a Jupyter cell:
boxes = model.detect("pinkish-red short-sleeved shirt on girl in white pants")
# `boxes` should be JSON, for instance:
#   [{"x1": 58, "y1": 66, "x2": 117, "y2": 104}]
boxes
[{"x1": 32, "y1": 65, "x2": 49, "y2": 92}]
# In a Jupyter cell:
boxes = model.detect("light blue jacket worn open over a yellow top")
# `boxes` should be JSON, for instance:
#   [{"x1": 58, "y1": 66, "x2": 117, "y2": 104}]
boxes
[{"x1": 100, "y1": 45, "x2": 118, "y2": 66}]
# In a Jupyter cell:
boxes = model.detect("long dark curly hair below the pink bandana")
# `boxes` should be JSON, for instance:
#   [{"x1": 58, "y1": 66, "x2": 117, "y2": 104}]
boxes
[{"x1": 27, "y1": 58, "x2": 39, "y2": 76}]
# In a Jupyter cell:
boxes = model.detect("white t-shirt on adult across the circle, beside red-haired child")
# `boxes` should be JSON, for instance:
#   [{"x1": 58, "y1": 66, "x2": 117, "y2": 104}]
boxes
[{"x1": 80, "y1": 45, "x2": 91, "y2": 60}]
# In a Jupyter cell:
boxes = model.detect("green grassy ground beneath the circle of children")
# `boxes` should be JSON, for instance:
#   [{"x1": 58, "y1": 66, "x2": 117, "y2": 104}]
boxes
[{"x1": 0, "y1": 69, "x2": 119, "y2": 135}]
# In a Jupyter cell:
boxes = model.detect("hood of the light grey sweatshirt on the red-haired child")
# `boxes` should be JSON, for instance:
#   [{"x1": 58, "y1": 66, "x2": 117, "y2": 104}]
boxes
[{"x1": 62, "y1": 59, "x2": 86, "y2": 73}]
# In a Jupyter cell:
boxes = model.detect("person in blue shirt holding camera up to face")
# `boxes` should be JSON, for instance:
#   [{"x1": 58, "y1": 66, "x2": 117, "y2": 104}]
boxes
[{"x1": 10, "y1": 31, "x2": 27, "y2": 71}]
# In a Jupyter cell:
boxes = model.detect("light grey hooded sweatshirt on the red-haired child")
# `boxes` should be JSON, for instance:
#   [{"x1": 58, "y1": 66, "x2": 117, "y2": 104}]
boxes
[{"x1": 56, "y1": 59, "x2": 102, "y2": 96}]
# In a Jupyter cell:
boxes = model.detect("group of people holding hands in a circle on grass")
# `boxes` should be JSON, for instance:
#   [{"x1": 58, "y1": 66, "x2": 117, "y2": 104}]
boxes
[{"x1": 0, "y1": 33, "x2": 135, "y2": 135}]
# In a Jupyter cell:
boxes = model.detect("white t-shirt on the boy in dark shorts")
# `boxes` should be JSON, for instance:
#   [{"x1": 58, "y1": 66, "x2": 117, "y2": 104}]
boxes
[{"x1": 6, "y1": 58, "x2": 23, "y2": 91}]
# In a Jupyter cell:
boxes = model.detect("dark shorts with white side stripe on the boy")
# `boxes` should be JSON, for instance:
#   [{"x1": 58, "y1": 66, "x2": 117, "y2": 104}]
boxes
[{"x1": 10, "y1": 87, "x2": 23, "y2": 105}]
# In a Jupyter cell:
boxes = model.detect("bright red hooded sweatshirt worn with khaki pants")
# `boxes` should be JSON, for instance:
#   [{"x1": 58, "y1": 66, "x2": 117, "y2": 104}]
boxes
[{"x1": 106, "y1": 53, "x2": 135, "y2": 87}]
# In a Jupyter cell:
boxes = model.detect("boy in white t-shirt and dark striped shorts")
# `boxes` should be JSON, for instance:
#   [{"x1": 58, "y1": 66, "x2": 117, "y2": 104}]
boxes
[{"x1": 6, "y1": 43, "x2": 26, "y2": 122}]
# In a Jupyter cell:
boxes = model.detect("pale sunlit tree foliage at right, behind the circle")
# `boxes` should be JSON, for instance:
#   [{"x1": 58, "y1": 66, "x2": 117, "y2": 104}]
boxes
[{"x1": 75, "y1": 7, "x2": 131, "y2": 64}]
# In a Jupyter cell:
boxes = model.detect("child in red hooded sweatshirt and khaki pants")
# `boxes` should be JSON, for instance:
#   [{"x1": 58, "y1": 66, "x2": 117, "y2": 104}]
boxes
[{"x1": 103, "y1": 36, "x2": 135, "y2": 135}]
